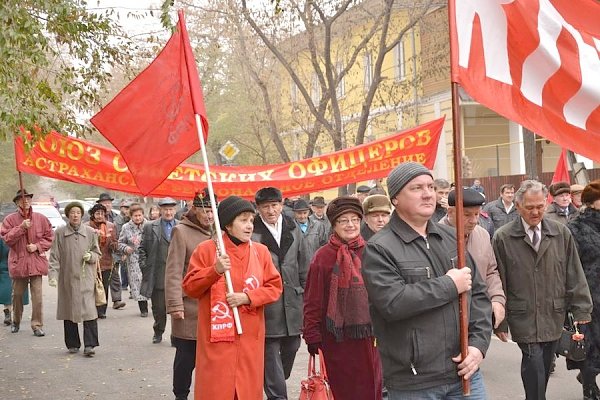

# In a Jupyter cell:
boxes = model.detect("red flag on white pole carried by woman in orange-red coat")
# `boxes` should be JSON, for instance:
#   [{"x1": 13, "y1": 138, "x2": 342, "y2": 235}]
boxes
[{"x1": 91, "y1": 11, "x2": 208, "y2": 194}]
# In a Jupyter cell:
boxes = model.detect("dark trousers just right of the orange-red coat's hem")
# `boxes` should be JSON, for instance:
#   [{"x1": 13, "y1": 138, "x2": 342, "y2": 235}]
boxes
[{"x1": 264, "y1": 335, "x2": 300, "y2": 400}]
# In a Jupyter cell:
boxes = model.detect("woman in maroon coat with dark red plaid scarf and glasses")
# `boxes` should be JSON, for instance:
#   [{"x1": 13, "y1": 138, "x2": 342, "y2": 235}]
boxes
[{"x1": 304, "y1": 197, "x2": 382, "y2": 400}]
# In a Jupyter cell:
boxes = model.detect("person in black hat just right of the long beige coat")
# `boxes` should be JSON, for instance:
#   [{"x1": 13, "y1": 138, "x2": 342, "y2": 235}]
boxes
[{"x1": 85, "y1": 203, "x2": 125, "y2": 319}]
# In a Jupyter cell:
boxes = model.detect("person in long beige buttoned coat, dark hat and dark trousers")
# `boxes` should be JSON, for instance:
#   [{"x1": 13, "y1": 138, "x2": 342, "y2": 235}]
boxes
[{"x1": 48, "y1": 202, "x2": 101, "y2": 357}]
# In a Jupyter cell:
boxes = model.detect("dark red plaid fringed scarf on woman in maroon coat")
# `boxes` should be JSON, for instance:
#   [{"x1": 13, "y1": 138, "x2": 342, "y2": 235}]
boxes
[{"x1": 326, "y1": 234, "x2": 373, "y2": 342}]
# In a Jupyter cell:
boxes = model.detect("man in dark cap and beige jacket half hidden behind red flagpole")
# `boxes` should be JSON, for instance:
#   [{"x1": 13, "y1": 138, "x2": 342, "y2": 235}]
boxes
[{"x1": 439, "y1": 188, "x2": 506, "y2": 328}]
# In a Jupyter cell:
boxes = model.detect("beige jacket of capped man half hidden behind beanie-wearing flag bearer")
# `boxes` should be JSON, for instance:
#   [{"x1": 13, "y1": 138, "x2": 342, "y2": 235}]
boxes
[{"x1": 439, "y1": 216, "x2": 506, "y2": 306}]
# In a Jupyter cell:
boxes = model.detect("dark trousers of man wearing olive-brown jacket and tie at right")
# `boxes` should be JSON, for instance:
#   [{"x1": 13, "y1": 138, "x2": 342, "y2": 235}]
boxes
[{"x1": 517, "y1": 341, "x2": 558, "y2": 400}]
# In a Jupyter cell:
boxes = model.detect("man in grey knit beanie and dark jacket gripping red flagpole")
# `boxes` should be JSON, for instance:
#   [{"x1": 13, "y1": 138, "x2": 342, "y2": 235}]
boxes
[{"x1": 362, "y1": 162, "x2": 492, "y2": 399}]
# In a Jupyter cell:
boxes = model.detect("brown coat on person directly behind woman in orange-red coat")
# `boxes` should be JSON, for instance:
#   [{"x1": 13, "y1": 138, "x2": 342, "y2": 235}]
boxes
[{"x1": 165, "y1": 217, "x2": 211, "y2": 340}]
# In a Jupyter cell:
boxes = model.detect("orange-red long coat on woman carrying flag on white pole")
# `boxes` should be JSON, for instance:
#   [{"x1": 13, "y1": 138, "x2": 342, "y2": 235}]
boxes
[{"x1": 183, "y1": 235, "x2": 283, "y2": 400}]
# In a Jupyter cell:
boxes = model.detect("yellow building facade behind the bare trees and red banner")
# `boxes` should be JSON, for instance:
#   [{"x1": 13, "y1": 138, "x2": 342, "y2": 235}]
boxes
[{"x1": 278, "y1": 1, "x2": 596, "y2": 186}]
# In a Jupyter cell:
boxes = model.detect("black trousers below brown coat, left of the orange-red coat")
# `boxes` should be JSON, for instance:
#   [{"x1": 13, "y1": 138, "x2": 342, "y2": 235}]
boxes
[{"x1": 171, "y1": 336, "x2": 196, "y2": 400}]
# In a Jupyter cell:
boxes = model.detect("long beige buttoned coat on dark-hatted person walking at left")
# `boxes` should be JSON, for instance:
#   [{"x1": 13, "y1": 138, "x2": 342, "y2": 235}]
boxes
[{"x1": 48, "y1": 224, "x2": 100, "y2": 322}]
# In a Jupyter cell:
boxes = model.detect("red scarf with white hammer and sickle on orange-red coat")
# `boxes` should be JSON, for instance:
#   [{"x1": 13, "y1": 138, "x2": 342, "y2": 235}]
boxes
[{"x1": 210, "y1": 235, "x2": 263, "y2": 343}]
